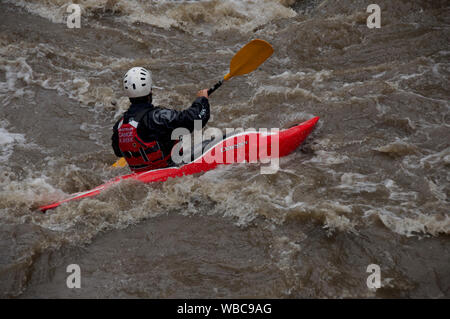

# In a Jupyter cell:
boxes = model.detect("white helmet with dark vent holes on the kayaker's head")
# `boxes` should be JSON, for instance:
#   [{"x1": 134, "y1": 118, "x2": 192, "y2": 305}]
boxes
[{"x1": 123, "y1": 67, "x2": 152, "y2": 97}]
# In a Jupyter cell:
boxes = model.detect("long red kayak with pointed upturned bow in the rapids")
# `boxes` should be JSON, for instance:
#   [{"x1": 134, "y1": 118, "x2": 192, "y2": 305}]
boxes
[{"x1": 39, "y1": 117, "x2": 319, "y2": 212}]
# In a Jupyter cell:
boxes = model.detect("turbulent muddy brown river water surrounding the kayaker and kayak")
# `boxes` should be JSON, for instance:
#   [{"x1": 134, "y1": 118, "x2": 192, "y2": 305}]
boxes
[{"x1": 0, "y1": 0, "x2": 450, "y2": 298}]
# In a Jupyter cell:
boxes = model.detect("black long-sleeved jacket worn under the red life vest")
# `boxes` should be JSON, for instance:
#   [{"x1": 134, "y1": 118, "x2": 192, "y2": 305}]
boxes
[{"x1": 111, "y1": 97, "x2": 210, "y2": 157}]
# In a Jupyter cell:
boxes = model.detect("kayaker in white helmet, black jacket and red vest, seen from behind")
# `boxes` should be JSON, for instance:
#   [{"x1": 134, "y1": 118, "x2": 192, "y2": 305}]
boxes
[{"x1": 111, "y1": 67, "x2": 210, "y2": 172}]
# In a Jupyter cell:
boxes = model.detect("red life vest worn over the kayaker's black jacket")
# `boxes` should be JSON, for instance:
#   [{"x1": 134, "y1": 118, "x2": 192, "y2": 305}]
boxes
[{"x1": 118, "y1": 110, "x2": 170, "y2": 173}]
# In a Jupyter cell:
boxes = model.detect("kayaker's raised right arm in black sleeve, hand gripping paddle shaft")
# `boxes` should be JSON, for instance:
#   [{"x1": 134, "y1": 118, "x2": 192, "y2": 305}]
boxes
[{"x1": 147, "y1": 90, "x2": 210, "y2": 132}]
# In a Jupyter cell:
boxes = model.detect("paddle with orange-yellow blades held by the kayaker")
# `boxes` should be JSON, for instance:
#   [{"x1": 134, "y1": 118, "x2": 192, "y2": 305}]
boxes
[{"x1": 112, "y1": 39, "x2": 273, "y2": 167}]
